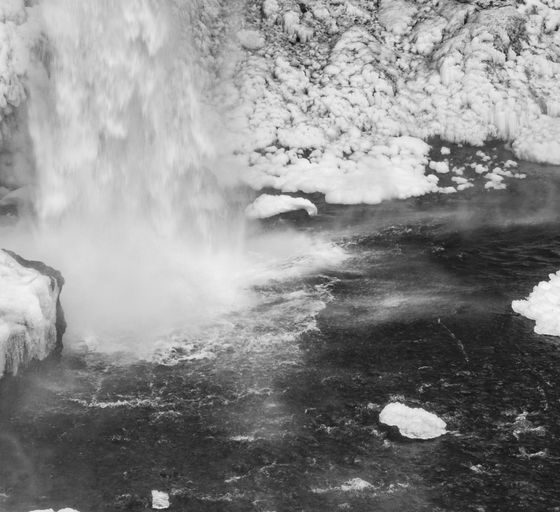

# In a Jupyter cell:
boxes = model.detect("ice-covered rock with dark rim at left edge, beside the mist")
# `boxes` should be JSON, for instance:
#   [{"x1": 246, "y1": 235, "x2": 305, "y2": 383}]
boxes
[{"x1": 0, "y1": 250, "x2": 66, "y2": 377}]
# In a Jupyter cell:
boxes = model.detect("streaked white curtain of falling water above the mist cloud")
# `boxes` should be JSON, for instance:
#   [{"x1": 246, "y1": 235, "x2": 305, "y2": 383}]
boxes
[{"x1": 30, "y1": 0, "x2": 236, "y2": 236}]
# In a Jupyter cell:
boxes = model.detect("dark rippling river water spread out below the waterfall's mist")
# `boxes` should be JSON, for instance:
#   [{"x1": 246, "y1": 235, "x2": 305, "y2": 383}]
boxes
[{"x1": 0, "y1": 148, "x2": 560, "y2": 512}]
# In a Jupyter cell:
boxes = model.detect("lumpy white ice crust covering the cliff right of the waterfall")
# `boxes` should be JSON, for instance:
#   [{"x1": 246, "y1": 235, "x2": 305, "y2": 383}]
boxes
[{"x1": 225, "y1": 0, "x2": 560, "y2": 203}]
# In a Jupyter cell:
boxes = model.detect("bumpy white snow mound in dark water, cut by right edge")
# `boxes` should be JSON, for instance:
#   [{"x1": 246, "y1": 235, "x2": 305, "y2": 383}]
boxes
[{"x1": 511, "y1": 271, "x2": 560, "y2": 336}]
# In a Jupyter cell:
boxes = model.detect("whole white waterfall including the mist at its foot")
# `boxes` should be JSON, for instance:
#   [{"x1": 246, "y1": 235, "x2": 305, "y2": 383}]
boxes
[{"x1": 14, "y1": 0, "x2": 249, "y2": 348}]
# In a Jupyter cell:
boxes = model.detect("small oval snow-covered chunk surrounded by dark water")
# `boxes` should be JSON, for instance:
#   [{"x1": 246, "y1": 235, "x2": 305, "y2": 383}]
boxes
[{"x1": 379, "y1": 402, "x2": 446, "y2": 439}]
